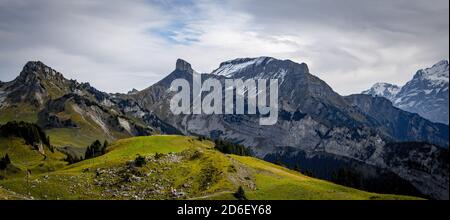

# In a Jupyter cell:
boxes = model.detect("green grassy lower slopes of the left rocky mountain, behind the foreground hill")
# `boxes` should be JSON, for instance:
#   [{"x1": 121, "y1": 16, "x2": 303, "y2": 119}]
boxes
[{"x1": 0, "y1": 99, "x2": 145, "y2": 153}]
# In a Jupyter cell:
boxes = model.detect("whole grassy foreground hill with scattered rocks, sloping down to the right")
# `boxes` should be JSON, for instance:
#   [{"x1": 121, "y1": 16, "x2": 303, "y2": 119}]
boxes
[{"x1": 0, "y1": 136, "x2": 417, "y2": 200}]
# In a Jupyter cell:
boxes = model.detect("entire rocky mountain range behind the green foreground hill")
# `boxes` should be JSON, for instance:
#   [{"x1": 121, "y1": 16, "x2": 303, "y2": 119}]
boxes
[{"x1": 0, "y1": 57, "x2": 449, "y2": 199}]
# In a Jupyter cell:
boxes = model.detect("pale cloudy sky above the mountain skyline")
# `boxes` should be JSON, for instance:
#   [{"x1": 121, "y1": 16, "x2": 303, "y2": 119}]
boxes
[{"x1": 0, "y1": 0, "x2": 449, "y2": 94}]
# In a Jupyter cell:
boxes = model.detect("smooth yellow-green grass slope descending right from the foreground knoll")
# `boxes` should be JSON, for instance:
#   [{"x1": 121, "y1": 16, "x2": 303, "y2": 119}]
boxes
[{"x1": 232, "y1": 156, "x2": 417, "y2": 200}]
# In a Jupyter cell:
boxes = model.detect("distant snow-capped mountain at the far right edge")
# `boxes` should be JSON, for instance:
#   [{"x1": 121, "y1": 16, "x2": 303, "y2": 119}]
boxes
[{"x1": 362, "y1": 60, "x2": 449, "y2": 124}]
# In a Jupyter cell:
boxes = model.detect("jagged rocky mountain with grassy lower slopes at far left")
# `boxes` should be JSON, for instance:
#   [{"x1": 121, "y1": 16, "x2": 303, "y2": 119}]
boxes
[{"x1": 0, "y1": 61, "x2": 178, "y2": 147}]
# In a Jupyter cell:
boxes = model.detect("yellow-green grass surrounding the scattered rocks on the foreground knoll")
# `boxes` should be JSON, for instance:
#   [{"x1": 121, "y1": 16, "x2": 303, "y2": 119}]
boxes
[{"x1": 0, "y1": 136, "x2": 235, "y2": 199}]
